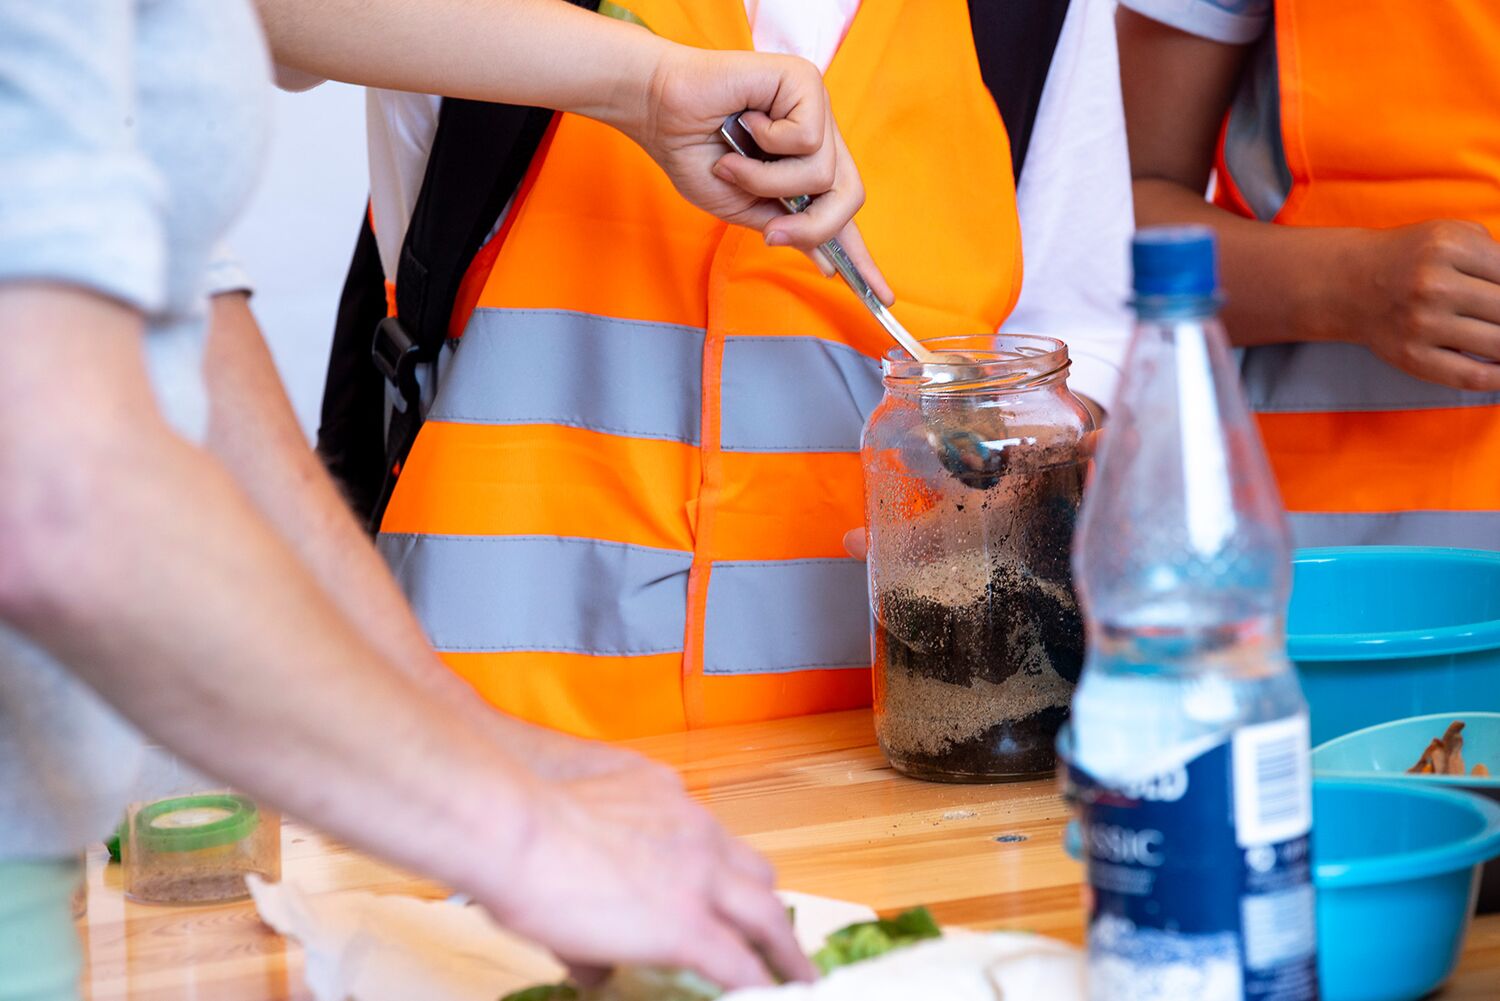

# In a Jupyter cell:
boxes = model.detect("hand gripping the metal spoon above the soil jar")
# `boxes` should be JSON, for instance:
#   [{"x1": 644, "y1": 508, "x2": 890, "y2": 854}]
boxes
[{"x1": 615, "y1": 45, "x2": 894, "y2": 303}]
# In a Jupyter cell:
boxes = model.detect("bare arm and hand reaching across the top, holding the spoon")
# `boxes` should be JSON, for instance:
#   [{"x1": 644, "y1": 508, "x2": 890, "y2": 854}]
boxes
[{"x1": 257, "y1": 0, "x2": 891, "y2": 302}]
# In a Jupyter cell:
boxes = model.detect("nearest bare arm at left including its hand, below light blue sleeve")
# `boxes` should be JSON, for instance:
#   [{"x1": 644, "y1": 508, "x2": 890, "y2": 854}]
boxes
[{"x1": 0, "y1": 281, "x2": 809, "y2": 986}]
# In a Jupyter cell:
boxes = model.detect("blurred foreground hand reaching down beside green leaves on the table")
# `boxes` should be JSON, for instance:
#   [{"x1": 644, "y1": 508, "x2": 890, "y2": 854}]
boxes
[{"x1": 479, "y1": 773, "x2": 813, "y2": 989}]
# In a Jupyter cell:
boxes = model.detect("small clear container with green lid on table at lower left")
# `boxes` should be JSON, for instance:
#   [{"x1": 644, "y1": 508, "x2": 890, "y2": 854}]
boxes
[{"x1": 120, "y1": 749, "x2": 281, "y2": 903}]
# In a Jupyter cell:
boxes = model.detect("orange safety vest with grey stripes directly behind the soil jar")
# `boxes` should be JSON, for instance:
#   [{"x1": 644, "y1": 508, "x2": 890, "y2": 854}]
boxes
[{"x1": 380, "y1": 0, "x2": 1022, "y2": 738}]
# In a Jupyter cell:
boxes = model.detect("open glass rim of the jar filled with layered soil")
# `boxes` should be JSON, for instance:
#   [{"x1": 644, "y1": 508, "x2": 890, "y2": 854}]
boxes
[{"x1": 881, "y1": 333, "x2": 1073, "y2": 393}]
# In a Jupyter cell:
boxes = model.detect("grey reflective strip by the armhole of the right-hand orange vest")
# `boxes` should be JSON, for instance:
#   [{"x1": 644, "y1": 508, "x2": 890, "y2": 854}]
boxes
[{"x1": 1224, "y1": 27, "x2": 1292, "y2": 222}]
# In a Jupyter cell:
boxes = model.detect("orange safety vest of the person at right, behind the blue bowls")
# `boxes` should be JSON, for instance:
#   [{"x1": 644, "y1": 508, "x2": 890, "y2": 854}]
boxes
[{"x1": 1218, "y1": 0, "x2": 1500, "y2": 549}]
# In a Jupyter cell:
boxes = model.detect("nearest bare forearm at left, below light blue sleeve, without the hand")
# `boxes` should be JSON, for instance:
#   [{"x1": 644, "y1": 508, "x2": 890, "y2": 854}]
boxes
[{"x1": 0, "y1": 282, "x2": 531, "y2": 890}]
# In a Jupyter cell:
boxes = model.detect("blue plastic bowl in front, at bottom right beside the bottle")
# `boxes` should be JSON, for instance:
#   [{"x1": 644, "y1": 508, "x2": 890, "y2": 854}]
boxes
[{"x1": 1064, "y1": 780, "x2": 1500, "y2": 1001}]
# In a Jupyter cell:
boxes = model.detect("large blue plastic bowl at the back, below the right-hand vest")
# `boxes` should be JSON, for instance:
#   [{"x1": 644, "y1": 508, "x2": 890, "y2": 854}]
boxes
[{"x1": 1287, "y1": 546, "x2": 1500, "y2": 750}]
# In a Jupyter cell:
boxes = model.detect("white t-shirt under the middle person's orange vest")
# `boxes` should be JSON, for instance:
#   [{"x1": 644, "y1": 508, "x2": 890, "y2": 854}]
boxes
[{"x1": 368, "y1": 0, "x2": 1136, "y2": 404}]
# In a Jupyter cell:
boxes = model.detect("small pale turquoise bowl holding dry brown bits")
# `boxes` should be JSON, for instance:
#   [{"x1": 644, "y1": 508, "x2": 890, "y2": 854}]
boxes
[{"x1": 1313, "y1": 713, "x2": 1500, "y2": 914}]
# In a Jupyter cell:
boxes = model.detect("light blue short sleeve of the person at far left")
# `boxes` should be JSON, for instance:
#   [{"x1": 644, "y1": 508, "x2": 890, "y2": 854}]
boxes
[{"x1": 0, "y1": 0, "x2": 167, "y2": 312}]
